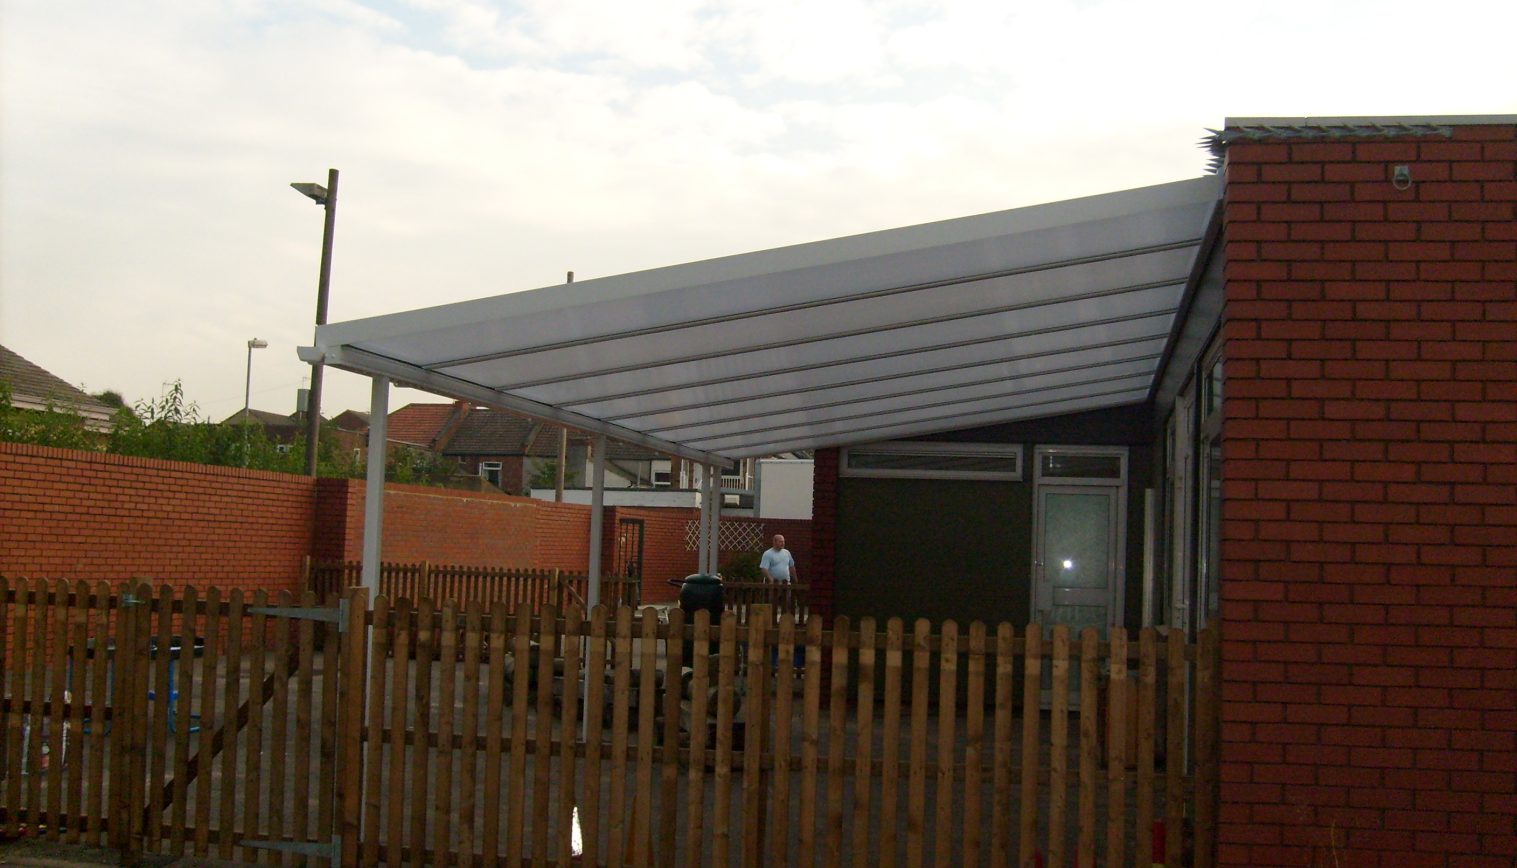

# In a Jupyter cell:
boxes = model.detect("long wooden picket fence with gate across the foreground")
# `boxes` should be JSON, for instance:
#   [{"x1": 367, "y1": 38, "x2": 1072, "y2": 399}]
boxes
[{"x1": 0, "y1": 580, "x2": 1218, "y2": 868}]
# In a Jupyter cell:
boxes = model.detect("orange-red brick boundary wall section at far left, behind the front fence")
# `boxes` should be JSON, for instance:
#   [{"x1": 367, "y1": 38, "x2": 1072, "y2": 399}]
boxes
[{"x1": 0, "y1": 443, "x2": 316, "y2": 590}]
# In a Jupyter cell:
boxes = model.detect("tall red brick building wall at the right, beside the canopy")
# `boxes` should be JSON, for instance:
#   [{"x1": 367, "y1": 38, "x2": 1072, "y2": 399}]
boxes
[{"x1": 1219, "y1": 126, "x2": 1517, "y2": 866}]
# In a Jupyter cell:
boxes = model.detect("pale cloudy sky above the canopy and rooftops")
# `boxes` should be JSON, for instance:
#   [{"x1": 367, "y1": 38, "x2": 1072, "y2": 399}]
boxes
[{"x1": 0, "y1": 0, "x2": 1517, "y2": 419}]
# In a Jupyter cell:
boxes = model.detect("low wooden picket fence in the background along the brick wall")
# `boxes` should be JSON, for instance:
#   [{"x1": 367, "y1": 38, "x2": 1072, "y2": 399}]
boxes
[{"x1": 300, "y1": 557, "x2": 642, "y2": 612}]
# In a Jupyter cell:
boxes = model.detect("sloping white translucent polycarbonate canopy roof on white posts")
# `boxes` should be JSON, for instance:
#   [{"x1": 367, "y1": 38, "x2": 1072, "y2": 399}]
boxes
[{"x1": 303, "y1": 176, "x2": 1220, "y2": 463}]
